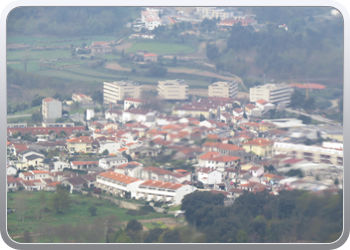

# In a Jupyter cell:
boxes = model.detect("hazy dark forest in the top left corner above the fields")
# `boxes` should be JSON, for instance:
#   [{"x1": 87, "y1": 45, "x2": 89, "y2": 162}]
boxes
[{"x1": 7, "y1": 7, "x2": 139, "y2": 36}]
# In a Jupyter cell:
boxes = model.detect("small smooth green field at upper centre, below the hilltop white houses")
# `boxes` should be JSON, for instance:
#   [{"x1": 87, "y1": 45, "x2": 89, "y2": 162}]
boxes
[{"x1": 126, "y1": 43, "x2": 197, "y2": 55}]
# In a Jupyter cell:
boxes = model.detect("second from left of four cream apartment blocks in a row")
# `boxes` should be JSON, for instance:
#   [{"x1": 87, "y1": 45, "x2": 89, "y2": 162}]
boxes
[{"x1": 157, "y1": 79, "x2": 188, "y2": 100}]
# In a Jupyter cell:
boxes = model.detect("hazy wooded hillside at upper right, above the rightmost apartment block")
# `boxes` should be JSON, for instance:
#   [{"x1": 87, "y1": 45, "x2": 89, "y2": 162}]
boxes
[{"x1": 213, "y1": 17, "x2": 343, "y2": 87}]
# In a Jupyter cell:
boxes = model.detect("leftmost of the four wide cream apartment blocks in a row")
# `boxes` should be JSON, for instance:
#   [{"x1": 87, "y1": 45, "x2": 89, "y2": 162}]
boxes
[{"x1": 103, "y1": 81, "x2": 142, "y2": 104}]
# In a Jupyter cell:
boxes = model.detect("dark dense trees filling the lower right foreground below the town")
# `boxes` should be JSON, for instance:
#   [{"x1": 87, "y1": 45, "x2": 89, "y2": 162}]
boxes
[{"x1": 181, "y1": 190, "x2": 343, "y2": 243}]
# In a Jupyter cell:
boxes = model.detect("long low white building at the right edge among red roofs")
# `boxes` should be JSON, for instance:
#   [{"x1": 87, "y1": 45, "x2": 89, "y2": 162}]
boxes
[{"x1": 273, "y1": 142, "x2": 343, "y2": 166}]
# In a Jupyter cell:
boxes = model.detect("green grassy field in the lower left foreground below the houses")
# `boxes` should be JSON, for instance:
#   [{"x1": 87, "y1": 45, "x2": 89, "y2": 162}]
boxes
[{"x1": 7, "y1": 191, "x2": 173, "y2": 238}]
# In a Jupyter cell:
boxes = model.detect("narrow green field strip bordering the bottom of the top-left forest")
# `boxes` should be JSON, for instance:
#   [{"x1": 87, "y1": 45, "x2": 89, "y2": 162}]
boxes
[{"x1": 6, "y1": 36, "x2": 119, "y2": 46}]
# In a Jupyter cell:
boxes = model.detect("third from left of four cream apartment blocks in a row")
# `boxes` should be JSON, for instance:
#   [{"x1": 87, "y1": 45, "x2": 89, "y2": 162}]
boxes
[{"x1": 208, "y1": 82, "x2": 238, "y2": 98}]
